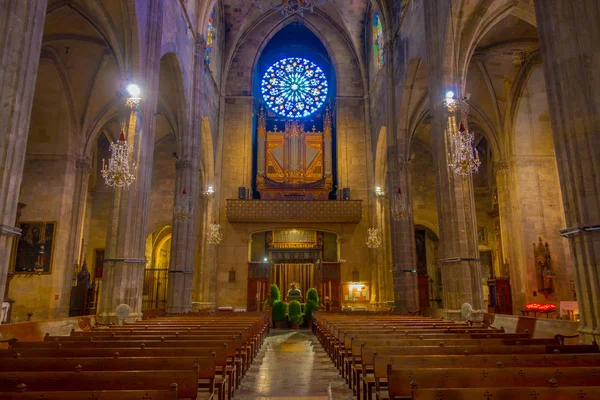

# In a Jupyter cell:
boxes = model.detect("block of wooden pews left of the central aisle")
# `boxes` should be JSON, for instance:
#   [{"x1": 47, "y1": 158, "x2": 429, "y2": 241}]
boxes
[{"x1": 0, "y1": 313, "x2": 270, "y2": 400}]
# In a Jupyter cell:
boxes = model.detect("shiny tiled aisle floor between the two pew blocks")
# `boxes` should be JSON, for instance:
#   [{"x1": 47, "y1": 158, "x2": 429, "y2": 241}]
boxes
[{"x1": 235, "y1": 330, "x2": 353, "y2": 400}]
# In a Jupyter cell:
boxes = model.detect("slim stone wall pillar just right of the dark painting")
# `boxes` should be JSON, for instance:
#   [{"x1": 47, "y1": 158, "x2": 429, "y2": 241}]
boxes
[{"x1": 57, "y1": 158, "x2": 91, "y2": 316}]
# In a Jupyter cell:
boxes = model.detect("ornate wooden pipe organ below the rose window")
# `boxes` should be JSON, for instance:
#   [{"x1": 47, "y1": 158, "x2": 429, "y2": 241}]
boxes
[{"x1": 256, "y1": 108, "x2": 333, "y2": 200}]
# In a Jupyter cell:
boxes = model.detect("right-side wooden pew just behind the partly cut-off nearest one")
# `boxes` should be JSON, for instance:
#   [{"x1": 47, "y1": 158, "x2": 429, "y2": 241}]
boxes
[{"x1": 387, "y1": 364, "x2": 600, "y2": 399}]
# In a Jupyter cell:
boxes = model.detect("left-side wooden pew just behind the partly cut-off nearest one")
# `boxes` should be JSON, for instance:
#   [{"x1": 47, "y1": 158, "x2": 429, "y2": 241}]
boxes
[{"x1": 0, "y1": 370, "x2": 204, "y2": 400}]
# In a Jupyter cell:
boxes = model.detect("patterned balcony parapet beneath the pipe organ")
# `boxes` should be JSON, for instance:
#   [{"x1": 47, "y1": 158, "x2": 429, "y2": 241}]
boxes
[{"x1": 226, "y1": 199, "x2": 363, "y2": 224}]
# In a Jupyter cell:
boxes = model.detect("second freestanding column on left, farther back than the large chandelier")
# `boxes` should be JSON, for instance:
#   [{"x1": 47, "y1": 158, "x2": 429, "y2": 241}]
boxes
[{"x1": 167, "y1": 36, "x2": 210, "y2": 313}]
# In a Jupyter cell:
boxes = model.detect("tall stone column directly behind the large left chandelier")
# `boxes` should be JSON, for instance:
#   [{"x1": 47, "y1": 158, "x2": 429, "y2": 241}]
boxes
[{"x1": 98, "y1": 1, "x2": 164, "y2": 323}]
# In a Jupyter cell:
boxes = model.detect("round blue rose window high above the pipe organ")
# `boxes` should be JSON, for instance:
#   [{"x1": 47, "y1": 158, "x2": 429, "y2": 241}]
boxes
[{"x1": 261, "y1": 57, "x2": 328, "y2": 118}]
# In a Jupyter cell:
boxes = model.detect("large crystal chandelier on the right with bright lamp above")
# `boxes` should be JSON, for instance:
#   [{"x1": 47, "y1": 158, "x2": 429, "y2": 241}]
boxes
[{"x1": 444, "y1": 92, "x2": 481, "y2": 176}]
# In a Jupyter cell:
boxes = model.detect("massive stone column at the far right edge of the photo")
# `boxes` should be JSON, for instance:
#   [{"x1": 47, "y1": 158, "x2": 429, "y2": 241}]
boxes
[{"x1": 535, "y1": 0, "x2": 600, "y2": 341}]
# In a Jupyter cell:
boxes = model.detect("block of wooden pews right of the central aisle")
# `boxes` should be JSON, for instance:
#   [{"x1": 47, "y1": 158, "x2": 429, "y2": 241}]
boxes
[{"x1": 313, "y1": 312, "x2": 600, "y2": 400}]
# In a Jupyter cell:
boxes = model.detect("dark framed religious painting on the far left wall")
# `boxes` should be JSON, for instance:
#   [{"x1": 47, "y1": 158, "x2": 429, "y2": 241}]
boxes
[{"x1": 14, "y1": 222, "x2": 56, "y2": 274}]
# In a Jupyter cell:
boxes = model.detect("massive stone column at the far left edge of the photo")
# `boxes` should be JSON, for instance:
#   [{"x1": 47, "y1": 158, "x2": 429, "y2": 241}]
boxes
[{"x1": 0, "y1": 0, "x2": 47, "y2": 304}]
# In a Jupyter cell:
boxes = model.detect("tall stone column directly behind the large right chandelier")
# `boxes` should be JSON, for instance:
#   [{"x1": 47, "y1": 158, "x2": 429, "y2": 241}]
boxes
[{"x1": 423, "y1": 0, "x2": 484, "y2": 319}]
